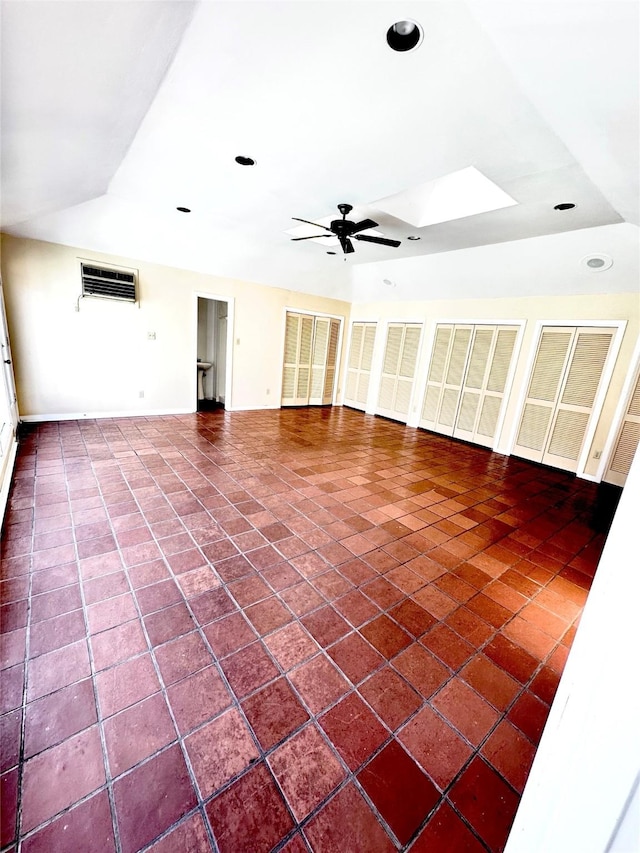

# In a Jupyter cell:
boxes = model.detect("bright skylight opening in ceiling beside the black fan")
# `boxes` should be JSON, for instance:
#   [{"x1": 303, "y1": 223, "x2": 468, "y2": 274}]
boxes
[{"x1": 371, "y1": 166, "x2": 518, "y2": 228}]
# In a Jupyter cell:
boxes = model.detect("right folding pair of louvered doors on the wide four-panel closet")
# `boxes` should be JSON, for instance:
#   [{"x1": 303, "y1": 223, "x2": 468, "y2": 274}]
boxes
[{"x1": 453, "y1": 326, "x2": 517, "y2": 447}]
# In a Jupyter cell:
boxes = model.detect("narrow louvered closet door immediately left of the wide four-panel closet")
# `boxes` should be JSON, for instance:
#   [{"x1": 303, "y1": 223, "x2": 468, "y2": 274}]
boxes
[{"x1": 376, "y1": 323, "x2": 422, "y2": 421}]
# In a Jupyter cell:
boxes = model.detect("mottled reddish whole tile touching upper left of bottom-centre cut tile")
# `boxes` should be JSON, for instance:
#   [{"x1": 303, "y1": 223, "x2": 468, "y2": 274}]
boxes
[{"x1": 268, "y1": 724, "x2": 346, "y2": 822}]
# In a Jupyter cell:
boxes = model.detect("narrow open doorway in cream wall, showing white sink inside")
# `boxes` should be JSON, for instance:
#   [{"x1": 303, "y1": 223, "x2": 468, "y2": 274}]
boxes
[{"x1": 196, "y1": 296, "x2": 229, "y2": 412}]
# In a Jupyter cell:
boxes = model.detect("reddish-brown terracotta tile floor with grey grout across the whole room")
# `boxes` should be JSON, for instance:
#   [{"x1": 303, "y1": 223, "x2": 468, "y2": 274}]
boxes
[{"x1": 0, "y1": 408, "x2": 607, "y2": 853}]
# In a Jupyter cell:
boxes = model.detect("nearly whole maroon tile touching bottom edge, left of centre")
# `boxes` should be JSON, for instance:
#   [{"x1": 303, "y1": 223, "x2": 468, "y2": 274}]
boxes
[{"x1": 113, "y1": 744, "x2": 197, "y2": 853}]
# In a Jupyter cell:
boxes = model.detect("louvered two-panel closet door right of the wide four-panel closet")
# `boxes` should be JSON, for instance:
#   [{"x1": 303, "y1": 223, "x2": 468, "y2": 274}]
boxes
[{"x1": 513, "y1": 326, "x2": 613, "y2": 471}]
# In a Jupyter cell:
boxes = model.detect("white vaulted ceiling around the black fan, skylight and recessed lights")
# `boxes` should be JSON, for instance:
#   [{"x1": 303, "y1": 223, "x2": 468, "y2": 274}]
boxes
[{"x1": 2, "y1": 0, "x2": 640, "y2": 296}]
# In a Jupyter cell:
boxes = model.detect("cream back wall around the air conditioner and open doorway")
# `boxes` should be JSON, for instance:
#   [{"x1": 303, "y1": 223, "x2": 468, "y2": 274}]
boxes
[{"x1": 2, "y1": 235, "x2": 350, "y2": 419}]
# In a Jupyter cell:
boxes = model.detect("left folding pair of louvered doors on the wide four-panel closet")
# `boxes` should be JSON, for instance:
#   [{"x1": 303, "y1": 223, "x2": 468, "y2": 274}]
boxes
[{"x1": 420, "y1": 325, "x2": 473, "y2": 435}]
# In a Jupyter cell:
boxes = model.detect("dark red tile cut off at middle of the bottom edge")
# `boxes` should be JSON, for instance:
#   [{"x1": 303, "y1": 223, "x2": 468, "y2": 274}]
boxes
[{"x1": 304, "y1": 783, "x2": 396, "y2": 853}]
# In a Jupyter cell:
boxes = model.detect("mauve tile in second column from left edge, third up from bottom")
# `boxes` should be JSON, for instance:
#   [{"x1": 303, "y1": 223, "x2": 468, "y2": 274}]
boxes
[{"x1": 24, "y1": 679, "x2": 98, "y2": 758}]
